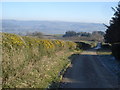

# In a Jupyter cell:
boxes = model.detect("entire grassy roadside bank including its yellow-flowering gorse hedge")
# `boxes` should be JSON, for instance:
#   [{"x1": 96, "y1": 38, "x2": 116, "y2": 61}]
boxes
[{"x1": 1, "y1": 33, "x2": 76, "y2": 88}]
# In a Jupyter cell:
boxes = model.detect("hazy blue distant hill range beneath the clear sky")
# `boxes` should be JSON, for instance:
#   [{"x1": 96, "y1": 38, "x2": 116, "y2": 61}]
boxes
[{"x1": 2, "y1": 20, "x2": 105, "y2": 34}]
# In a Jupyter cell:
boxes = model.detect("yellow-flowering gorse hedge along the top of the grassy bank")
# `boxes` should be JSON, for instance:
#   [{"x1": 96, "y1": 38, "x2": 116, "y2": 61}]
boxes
[{"x1": 2, "y1": 33, "x2": 76, "y2": 56}]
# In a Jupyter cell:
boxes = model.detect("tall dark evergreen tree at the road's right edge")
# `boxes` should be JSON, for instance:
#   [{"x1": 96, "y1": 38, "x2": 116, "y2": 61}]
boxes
[{"x1": 105, "y1": 2, "x2": 120, "y2": 61}]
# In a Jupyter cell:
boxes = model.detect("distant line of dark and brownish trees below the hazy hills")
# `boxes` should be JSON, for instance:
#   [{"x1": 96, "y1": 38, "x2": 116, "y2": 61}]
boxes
[{"x1": 63, "y1": 31, "x2": 105, "y2": 42}]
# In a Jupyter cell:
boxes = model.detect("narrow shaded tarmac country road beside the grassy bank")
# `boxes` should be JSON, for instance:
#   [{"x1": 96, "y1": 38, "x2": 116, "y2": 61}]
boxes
[{"x1": 60, "y1": 50, "x2": 118, "y2": 88}]
